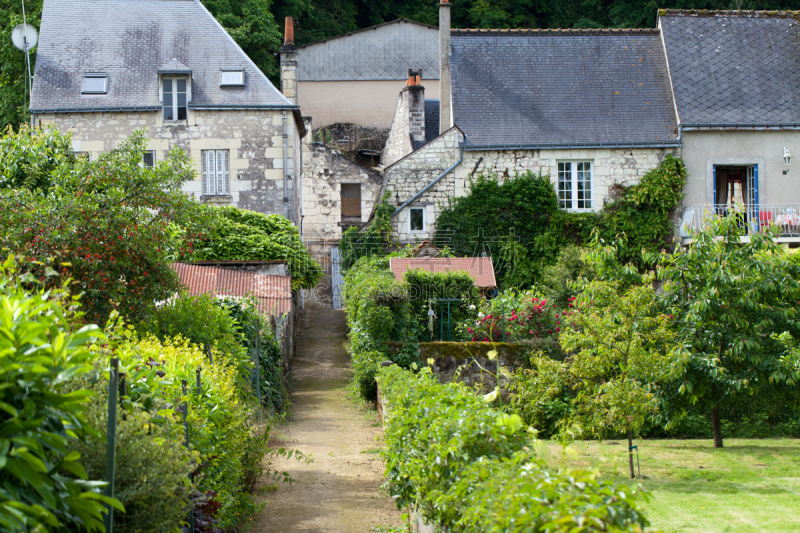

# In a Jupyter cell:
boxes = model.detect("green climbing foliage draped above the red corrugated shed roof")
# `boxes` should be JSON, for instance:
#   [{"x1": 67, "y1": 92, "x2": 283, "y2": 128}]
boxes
[{"x1": 181, "y1": 206, "x2": 322, "y2": 289}]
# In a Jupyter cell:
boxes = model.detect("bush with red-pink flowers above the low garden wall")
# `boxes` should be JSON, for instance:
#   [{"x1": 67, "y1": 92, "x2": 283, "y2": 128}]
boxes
[{"x1": 460, "y1": 289, "x2": 575, "y2": 342}]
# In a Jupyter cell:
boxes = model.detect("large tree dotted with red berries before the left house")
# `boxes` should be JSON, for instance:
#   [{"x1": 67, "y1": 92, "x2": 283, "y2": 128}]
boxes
[{"x1": 0, "y1": 126, "x2": 197, "y2": 323}]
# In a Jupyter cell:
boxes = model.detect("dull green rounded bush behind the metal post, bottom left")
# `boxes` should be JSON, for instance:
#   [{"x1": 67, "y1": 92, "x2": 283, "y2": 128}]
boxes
[{"x1": 72, "y1": 379, "x2": 195, "y2": 533}]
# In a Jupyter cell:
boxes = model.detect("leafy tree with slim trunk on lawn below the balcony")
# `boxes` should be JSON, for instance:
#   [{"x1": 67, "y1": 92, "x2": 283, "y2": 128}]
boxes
[{"x1": 660, "y1": 213, "x2": 800, "y2": 448}]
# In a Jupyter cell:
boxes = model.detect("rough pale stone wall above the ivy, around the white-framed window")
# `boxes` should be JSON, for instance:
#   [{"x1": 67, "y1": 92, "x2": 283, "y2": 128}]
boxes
[{"x1": 385, "y1": 134, "x2": 676, "y2": 242}]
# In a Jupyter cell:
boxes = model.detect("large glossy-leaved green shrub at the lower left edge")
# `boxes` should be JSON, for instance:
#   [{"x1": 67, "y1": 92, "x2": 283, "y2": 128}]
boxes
[{"x1": 0, "y1": 258, "x2": 123, "y2": 533}]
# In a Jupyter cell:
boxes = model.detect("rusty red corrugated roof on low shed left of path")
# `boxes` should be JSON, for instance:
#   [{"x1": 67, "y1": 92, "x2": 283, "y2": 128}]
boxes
[{"x1": 172, "y1": 263, "x2": 292, "y2": 316}]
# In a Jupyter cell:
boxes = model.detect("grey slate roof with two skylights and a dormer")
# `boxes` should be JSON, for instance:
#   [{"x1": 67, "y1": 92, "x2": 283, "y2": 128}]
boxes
[{"x1": 31, "y1": 0, "x2": 292, "y2": 110}]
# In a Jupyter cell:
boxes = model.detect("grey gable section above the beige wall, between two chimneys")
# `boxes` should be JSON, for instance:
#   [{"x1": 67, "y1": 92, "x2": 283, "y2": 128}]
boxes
[{"x1": 297, "y1": 19, "x2": 439, "y2": 81}]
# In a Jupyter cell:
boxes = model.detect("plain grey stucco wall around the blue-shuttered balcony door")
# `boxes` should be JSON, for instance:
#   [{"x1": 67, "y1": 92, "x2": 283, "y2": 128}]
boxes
[{"x1": 682, "y1": 130, "x2": 800, "y2": 207}]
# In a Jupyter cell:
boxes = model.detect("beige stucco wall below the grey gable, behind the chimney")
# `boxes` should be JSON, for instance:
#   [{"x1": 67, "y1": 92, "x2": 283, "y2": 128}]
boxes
[{"x1": 297, "y1": 80, "x2": 439, "y2": 129}]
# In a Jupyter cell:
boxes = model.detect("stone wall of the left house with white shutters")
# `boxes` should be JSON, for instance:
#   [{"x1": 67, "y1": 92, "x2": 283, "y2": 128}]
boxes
[{"x1": 36, "y1": 109, "x2": 300, "y2": 221}]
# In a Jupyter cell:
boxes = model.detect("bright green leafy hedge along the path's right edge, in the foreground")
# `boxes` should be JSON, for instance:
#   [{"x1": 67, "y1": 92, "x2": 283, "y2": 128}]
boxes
[{"x1": 378, "y1": 366, "x2": 647, "y2": 533}]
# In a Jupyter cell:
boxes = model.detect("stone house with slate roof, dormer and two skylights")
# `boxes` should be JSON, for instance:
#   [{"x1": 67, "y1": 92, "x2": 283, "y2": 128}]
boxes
[{"x1": 31, "y1": 0, "x2": 305, "y2": 220}]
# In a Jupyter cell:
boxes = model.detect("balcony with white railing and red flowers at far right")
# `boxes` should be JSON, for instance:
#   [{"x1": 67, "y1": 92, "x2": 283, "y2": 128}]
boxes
[{"x1": 679, "y1": 204, "x2": 800, "y2": 244}]
